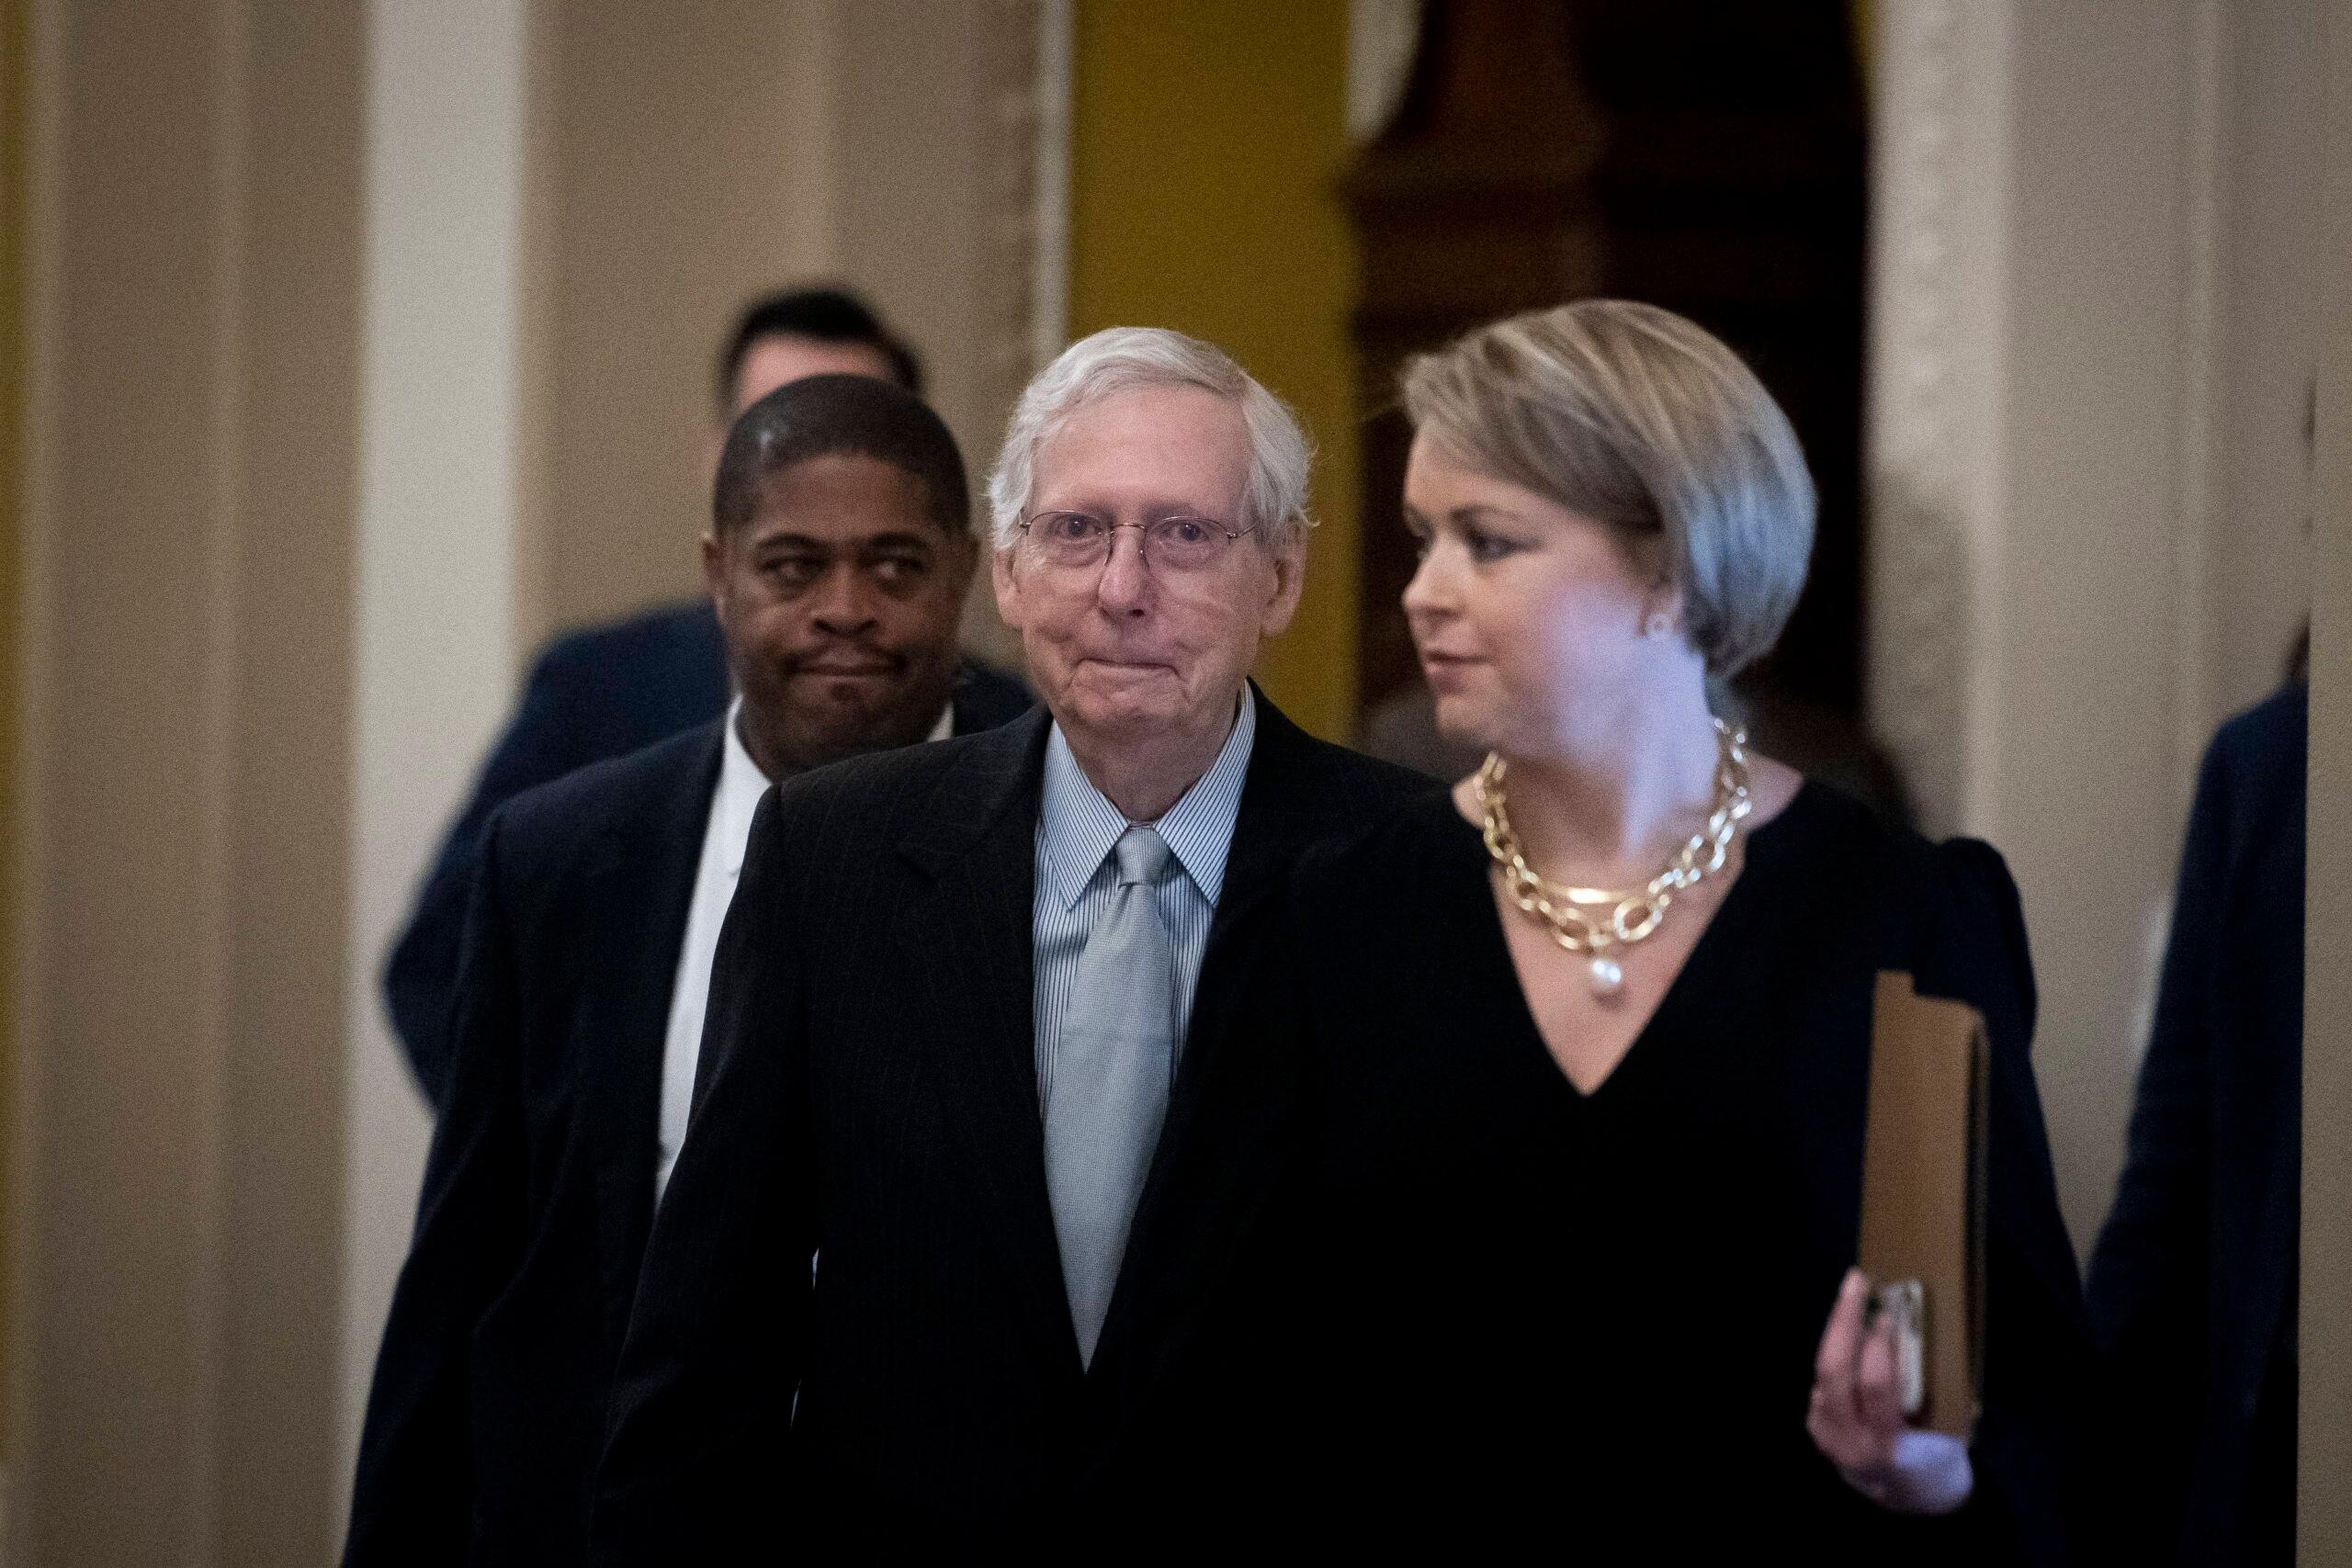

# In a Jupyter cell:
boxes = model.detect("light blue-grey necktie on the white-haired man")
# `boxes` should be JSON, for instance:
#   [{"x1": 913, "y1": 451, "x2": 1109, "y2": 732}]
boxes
[{"x1": 1045, "y1": 828, "x2": 1176, "y2": 1366}]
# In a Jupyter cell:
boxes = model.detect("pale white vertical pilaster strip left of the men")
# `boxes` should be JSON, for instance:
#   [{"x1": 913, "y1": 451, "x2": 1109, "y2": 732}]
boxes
[{"x1": 332, "y1": 0, "x2": 534, "y2": 1526}]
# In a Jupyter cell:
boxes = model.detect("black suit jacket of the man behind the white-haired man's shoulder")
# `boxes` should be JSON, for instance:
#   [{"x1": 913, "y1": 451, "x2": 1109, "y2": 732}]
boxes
[{"x1": 344, "y1": 677, "x2": 1039, "y2": 1563}]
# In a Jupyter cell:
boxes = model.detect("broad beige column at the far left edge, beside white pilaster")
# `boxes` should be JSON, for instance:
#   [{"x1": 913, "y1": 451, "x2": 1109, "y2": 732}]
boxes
[{"x1": 9, "y1": 0, "x2": 362, "y2": 1563}]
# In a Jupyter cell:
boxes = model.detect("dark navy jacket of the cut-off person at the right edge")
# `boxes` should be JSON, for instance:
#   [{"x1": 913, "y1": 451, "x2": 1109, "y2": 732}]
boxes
[{"x1": 2088, "y1": 682, "x2": 2310, "y2": 1563}]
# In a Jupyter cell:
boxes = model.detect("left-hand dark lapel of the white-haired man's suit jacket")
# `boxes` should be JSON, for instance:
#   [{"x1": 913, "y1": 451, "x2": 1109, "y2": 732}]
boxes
[{"x1": 899, "y1": 710, "x2": 1077, "y2": 1373}]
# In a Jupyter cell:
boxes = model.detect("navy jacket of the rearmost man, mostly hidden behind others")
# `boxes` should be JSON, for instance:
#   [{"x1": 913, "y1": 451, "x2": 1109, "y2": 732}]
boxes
[{"x1": 383, "y1": 600, "x2": 1030, "y2": 1112}]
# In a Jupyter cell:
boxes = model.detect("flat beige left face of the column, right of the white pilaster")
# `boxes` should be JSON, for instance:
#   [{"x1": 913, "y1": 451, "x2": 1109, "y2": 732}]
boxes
[{"x1": 520, "y1": 0, "x2": 842, "y2": 635}]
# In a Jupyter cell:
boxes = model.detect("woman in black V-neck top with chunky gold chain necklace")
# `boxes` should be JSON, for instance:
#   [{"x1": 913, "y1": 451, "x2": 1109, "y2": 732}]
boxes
[{"x1": 1167, "y1": 301, "x2": 2088, "y2": 1563}]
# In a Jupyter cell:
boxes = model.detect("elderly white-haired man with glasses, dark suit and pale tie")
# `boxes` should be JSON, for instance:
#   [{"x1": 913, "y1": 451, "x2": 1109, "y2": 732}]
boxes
[{"x1": 593, "y1": 327, "x2": 1428, "y2": 1563}]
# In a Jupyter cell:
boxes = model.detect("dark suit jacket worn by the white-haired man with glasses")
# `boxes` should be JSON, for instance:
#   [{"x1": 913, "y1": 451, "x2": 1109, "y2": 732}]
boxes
[{"x1": 593, "y1": 698, "x2": 1432, "y2": 1563}]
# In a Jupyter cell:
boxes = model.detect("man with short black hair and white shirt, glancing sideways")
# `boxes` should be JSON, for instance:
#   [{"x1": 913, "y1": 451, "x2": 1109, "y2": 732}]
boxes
[{"x1": 344, "y1": 374, "x2": 1028, "y2": 1568}]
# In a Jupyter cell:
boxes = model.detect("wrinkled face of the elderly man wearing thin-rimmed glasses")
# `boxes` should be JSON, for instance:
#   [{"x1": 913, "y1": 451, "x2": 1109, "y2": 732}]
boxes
[{"x1": 992, "y1": 388, "x2": 1303, "y2": 745}]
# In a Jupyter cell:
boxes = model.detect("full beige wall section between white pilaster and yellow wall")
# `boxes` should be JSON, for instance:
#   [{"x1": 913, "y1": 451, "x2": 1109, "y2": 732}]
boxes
[{"x1": 517, "y1": 0, "x2": 1039, "y2": 659}]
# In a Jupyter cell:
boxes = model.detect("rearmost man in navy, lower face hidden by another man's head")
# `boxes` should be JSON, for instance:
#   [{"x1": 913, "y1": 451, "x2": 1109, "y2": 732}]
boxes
[{"x1": 383, "y1": 287, "x2": 964, "y2": 1112}]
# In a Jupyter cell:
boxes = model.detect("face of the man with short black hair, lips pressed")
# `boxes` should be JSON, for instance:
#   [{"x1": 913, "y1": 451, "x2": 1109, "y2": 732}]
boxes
[{"x1": 703, "y1": 454, "x2": 978, "y2": 776}]
